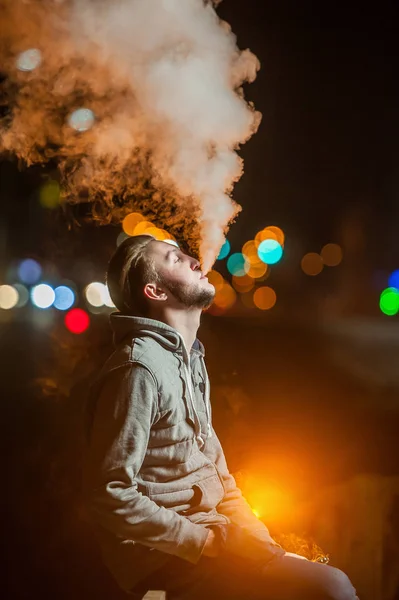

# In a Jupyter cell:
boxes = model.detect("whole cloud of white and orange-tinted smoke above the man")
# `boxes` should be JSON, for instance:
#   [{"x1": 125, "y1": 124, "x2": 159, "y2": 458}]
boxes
[{"x1": 2, "y1": 0, "x2": 260, "y2": 269}]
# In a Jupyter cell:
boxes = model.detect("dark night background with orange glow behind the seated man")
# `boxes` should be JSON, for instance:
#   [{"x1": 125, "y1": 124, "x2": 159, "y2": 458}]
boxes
[{"x1": 0, "y1": 0, "x2": 399, "y2": 600}]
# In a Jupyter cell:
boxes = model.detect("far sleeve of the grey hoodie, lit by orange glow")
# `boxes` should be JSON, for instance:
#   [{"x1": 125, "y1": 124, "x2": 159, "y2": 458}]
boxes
[{"x1": 205, "y1": 428, "x2": 279, "y2": 546}]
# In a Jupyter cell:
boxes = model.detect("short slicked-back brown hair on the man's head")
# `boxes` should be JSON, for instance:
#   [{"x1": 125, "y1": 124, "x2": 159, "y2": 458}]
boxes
[{"x1": 107, "y1": 235, "x2": 158, "y2": 317}]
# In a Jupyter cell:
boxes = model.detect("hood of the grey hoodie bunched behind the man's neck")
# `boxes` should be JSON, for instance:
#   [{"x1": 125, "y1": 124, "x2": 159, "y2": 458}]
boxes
[{"x1": 110, "y1": 313, "x2": 204, "y2": 356}]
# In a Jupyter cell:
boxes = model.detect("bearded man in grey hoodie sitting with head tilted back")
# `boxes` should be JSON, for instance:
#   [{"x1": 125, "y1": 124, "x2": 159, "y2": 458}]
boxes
[{"x1": 84, "y1": 236, "x2": 356, "y2": 600}]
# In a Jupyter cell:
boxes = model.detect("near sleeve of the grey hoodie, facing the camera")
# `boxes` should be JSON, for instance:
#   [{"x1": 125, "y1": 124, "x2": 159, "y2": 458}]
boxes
[{"x1": 84, "y1": 363, "x2": 208, "y2": 563}]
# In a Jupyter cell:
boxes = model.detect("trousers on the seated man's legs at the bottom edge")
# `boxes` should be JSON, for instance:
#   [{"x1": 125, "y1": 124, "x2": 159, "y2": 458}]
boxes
[{"x1": 133, "y1": 554, "x2": 357, "y2": 600}]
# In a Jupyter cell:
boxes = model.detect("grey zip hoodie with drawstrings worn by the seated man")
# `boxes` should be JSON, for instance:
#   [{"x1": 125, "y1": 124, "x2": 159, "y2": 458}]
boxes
[{"x1": 84, "y1": 313, "x2": 280, "y2": 590}]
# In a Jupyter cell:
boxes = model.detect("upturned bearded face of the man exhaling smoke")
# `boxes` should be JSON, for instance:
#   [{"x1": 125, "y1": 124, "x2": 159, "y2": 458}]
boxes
[{"x1": 147, "y1": 241, "x2": 215, "y2": 309}]
